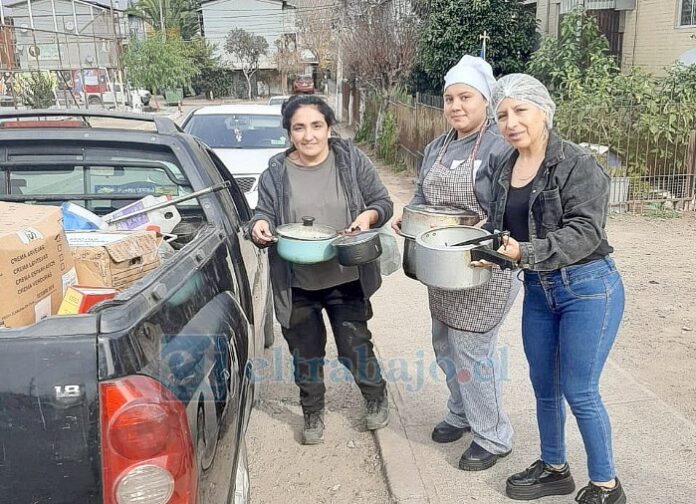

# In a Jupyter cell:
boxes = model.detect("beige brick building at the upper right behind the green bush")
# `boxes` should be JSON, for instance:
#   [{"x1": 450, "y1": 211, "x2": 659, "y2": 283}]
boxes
[{"x1": 525, "y1": 0, "x2": 696, "y2": 75}]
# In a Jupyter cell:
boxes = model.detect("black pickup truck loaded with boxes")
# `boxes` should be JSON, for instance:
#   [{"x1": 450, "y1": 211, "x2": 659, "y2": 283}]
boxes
[{"x1": 0, "y1": 110, "x2": 273, "y2": 504}]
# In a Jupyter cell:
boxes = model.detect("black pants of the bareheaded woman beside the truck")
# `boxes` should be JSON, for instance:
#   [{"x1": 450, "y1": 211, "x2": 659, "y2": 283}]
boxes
[{"x1": 283, "y1": 281, "x2": 386, "y2": 412}]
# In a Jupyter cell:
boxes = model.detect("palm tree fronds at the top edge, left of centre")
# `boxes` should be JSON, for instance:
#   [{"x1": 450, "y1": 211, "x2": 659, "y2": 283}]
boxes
[{"x1": 126, "y1": 0, "x2": 200, "y2": 40}]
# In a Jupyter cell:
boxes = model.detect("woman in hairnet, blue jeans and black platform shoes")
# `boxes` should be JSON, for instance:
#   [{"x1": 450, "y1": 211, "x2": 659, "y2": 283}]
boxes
[{"x1": 478, "y1": 74, "x2": 626, "y2": 504}]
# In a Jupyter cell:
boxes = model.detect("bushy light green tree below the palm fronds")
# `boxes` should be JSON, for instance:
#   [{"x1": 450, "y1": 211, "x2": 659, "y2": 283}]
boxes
[{"x1": 123, "y1": 34, "x2": 200, "y2": 108}]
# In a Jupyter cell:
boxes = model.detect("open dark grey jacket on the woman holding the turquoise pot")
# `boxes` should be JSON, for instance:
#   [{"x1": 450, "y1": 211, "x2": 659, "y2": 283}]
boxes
[{"x1": 249, "y1": 138, "x2": 394, "y2": 327}]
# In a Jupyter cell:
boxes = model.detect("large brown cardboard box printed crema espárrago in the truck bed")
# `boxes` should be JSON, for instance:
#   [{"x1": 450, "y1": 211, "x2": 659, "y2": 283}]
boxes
[{"x1": 0, "y1": 202, "x2": 75, "y2": 327}]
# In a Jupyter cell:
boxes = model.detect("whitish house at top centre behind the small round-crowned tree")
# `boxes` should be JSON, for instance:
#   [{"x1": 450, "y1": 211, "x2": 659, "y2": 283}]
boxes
[{"x1": 200, "y1": 0, "x2": 297, "y2": 70}]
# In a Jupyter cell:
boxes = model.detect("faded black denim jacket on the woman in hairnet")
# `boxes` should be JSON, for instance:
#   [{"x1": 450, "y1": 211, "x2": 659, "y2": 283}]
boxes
[{"x1": 484, "y1": 131, "x2": 610, "y2": 271}]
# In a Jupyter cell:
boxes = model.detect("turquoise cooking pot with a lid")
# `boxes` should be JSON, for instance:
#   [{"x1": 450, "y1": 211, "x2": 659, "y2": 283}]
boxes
[{"x1": 276, "y1": 217, "x2": 338, "y2": 264}]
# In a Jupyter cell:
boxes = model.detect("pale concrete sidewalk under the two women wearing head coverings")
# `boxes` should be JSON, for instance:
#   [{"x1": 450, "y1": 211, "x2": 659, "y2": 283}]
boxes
[{"x1": 371, "y1": 177, "x2": 696, "y2": 504}]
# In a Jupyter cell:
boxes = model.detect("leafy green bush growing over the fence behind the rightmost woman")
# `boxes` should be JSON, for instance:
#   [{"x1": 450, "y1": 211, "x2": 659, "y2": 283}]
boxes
[{"x1": 529, "y1": 10, "x2": 696, "y2": 198}]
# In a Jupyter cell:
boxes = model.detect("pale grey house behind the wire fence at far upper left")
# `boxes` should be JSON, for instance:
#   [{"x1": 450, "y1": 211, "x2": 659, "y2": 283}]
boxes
[{"x1": 3, "y1": 0, "x2": 143, "y2": 70}]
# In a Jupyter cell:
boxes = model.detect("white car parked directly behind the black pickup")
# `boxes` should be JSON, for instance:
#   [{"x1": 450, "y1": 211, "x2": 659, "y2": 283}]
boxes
[{"x1": 182, "y1": 105, "x2": 290, "y2": 209}]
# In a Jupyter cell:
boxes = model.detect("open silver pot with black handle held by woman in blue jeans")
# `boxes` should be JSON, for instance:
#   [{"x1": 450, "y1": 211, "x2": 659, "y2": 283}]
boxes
[{"x1": 416, "y1": 226, "x2": 517, "y2": 290}]
